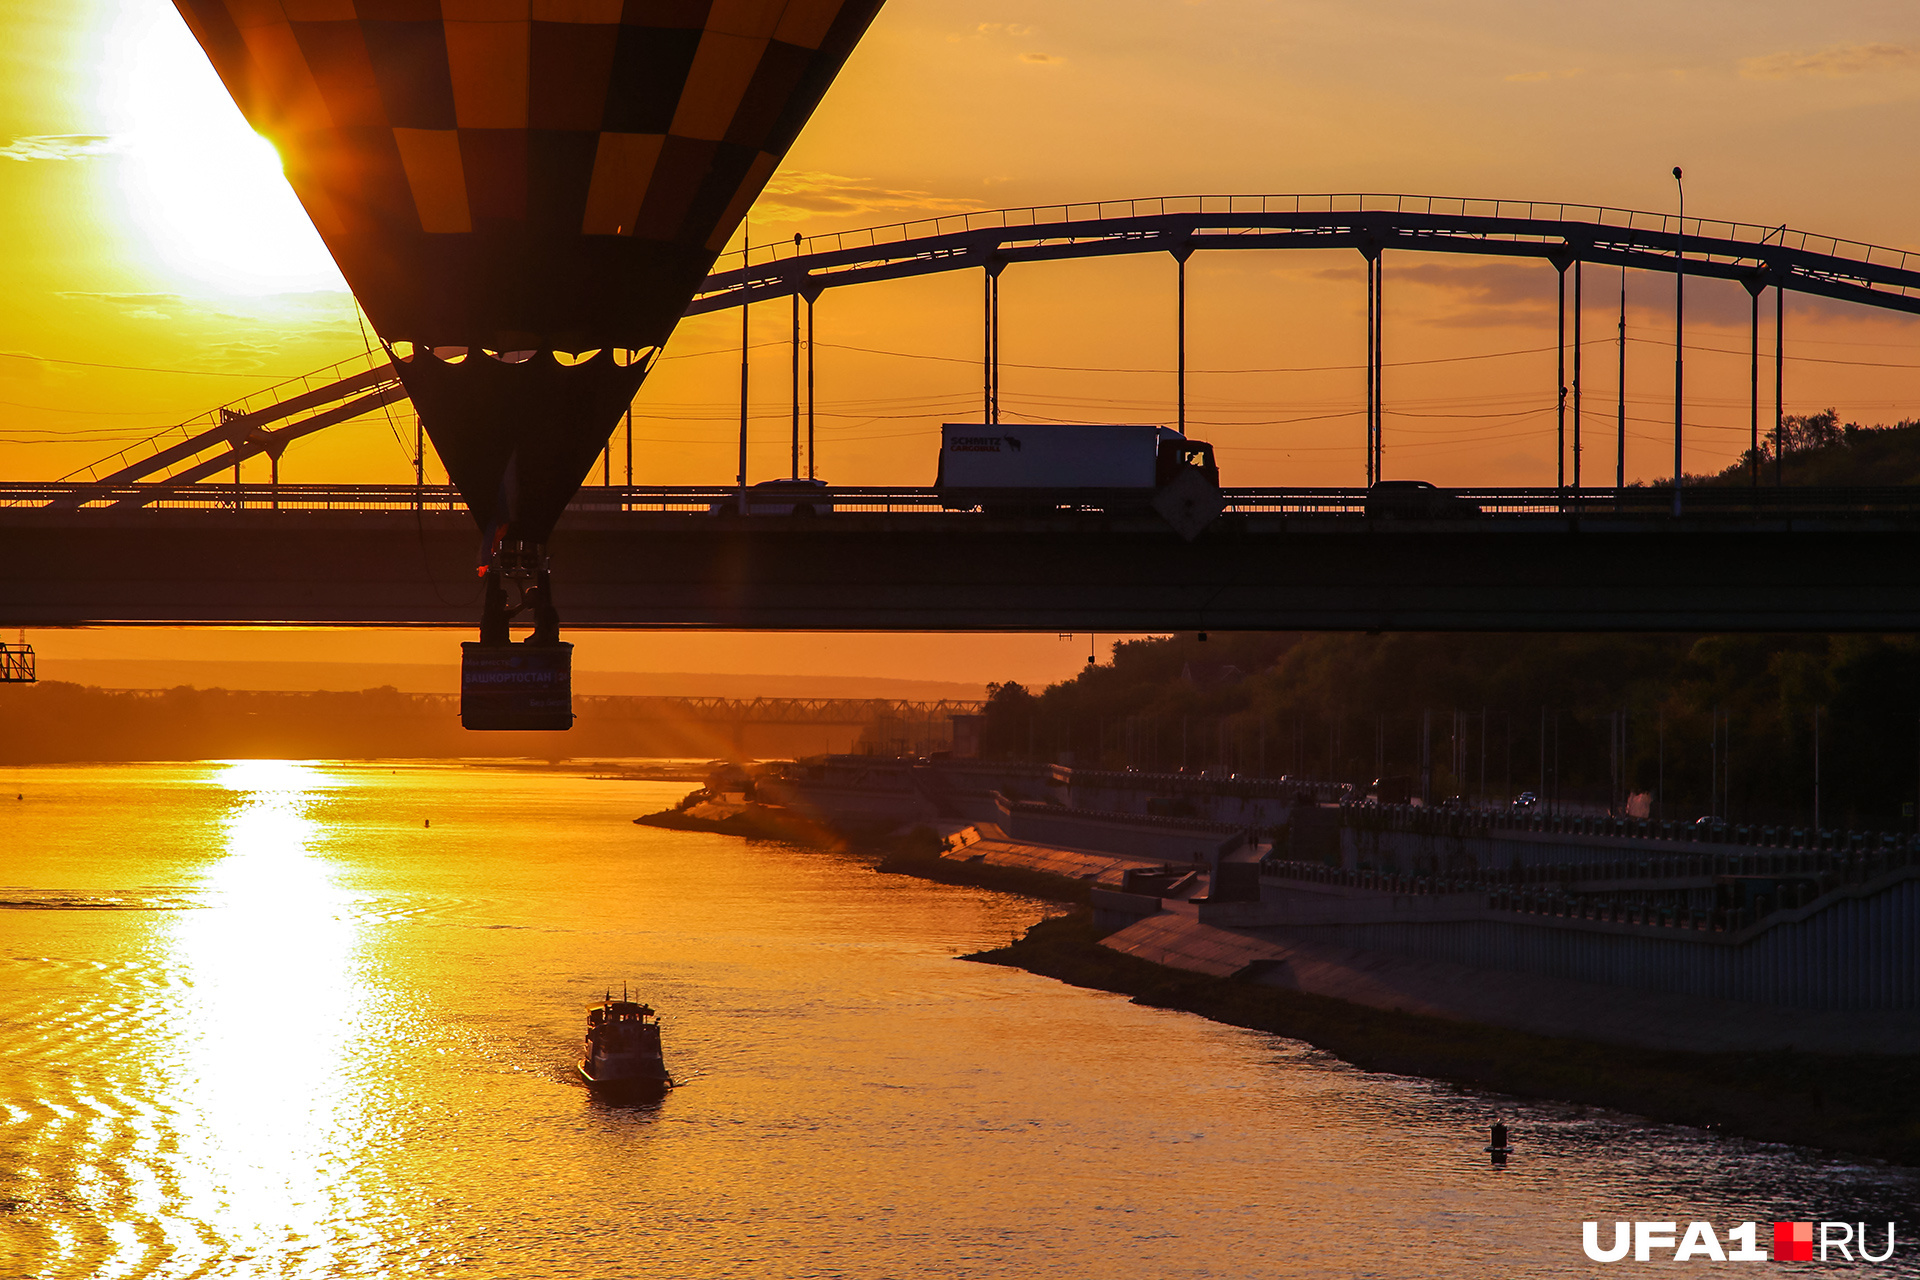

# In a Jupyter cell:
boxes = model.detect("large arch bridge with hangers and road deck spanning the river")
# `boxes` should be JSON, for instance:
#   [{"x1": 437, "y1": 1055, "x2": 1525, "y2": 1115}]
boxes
[{"x1": 11, "y1": 196, "x2": 1920, "y2": 631}]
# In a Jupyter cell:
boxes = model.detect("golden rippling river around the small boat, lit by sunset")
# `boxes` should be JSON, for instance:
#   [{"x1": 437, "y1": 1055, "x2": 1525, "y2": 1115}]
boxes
[{"x1": 0, "y1": 762, "x2": 1920, "y2": 1280}]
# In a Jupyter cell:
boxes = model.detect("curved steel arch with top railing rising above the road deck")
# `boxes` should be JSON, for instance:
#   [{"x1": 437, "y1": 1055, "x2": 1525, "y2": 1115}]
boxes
[{"x1": 60, "y1": 192, "x2": 1920, "y2": 507}]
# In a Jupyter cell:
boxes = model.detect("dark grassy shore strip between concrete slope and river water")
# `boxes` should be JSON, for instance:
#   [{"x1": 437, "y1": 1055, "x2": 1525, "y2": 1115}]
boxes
[{"x1": 964, "y1": 912, "x2": 1920, "y2": 1165}]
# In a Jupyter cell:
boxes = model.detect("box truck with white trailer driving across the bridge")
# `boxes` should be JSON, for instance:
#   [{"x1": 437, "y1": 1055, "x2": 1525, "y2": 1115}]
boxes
[{"x1": 933, "y1": 422, "x2": 1219, "y2": 509}]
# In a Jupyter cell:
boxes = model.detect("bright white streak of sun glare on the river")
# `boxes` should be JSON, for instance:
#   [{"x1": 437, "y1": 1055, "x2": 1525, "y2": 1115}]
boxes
[{"x1": 167, "y1": 762, "x2": 397, "y2": 1274}]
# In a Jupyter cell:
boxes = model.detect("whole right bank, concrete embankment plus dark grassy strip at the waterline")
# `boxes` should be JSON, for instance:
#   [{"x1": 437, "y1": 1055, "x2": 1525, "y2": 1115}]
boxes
[{"x1": 643, "y1": 760, "x2": 1920, "y2": 1161}]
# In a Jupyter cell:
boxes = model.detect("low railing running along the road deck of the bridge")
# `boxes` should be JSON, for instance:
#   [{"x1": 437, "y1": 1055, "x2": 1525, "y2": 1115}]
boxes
[{"x1": 11, "y1": 482, "x2": 1920, "y2": 520}]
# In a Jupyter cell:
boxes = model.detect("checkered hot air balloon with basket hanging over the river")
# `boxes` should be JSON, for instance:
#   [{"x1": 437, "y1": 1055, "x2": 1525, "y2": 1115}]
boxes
[{"x1": 175, "y1": 0, "x2": 881, "y2": 727}]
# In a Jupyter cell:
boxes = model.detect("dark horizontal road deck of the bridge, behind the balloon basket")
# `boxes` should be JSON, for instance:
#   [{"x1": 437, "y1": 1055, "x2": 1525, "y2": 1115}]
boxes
[{"x1": 0, "y1": 487, "x2": 1920, "y2": 631}]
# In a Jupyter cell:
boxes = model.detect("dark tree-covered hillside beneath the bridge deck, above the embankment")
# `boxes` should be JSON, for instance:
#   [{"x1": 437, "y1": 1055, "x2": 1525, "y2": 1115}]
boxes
[{"x1": 983, "y1": 631, "x2": 1920, "y2": 829}]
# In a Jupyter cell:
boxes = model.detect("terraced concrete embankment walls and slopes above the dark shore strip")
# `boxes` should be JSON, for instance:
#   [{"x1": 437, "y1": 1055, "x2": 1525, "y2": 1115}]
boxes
[{"x1": 760, "y1": 758, "x2": 1920, "y2": 1054}]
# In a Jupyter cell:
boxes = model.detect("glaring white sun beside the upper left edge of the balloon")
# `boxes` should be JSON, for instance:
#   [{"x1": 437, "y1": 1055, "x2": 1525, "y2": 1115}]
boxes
[{"x1": 100, "y1": 0, "x2": 346, "y2": 294}]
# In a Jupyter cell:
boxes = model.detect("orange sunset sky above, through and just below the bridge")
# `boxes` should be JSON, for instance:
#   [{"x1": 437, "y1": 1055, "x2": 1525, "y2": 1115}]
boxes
[{"x1": 0, "y1": 0, "x2": 1920, "y2": 679}]
